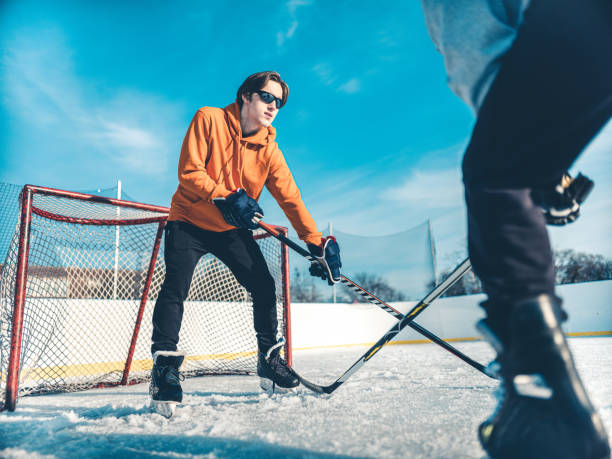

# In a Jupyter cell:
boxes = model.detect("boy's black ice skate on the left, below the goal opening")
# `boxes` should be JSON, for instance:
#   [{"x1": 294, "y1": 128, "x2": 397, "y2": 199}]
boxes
[{"x1": 149, "y1": 351, "x2": 185, "y2": 418}]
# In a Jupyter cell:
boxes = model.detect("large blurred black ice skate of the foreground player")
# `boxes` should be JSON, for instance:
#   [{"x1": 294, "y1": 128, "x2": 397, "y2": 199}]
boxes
[{"x1": 478, "y1": 295, "x2": 610, "y2": 459}]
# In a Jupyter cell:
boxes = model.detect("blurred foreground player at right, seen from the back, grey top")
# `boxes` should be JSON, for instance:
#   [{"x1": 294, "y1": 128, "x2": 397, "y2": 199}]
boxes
[{"x1": 421, "y1": 0, "x2": 612, "y2": 458}]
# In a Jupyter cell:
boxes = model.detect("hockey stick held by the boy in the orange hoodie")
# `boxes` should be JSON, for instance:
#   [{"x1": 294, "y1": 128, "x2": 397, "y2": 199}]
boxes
[{"x1": 258, "y1": 221, "x2": 491, "y2": 376}]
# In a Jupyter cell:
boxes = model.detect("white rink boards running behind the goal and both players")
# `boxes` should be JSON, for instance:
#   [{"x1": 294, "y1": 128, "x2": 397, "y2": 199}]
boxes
[{"x1": 11, "y1": 281, "x2": 612, "y2": 376}]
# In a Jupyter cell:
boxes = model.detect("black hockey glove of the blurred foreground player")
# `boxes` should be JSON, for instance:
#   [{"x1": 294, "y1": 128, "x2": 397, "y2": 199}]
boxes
[{"x1": 531, "y1": 173, "x2": 595, "y2": 226}]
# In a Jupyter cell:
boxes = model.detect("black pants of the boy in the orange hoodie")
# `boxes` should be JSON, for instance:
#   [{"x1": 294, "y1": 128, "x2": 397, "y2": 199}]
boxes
[{"x1": 151, "y1": 221, "x2": 278, "y2": 353}]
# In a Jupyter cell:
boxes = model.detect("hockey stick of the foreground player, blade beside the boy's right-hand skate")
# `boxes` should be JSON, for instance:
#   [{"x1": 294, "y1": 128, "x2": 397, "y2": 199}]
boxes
[{"x1": 298, "y1": 259, "x2": 471, "y2": 394}]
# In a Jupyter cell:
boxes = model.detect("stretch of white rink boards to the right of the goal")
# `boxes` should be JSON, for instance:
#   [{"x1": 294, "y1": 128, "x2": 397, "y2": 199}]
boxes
[{"x1": 291, "y1": 281, "x2": 612, "y2": 349}]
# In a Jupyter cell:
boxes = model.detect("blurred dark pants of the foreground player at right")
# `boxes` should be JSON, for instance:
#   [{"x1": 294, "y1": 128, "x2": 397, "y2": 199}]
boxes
[{"x1": 463, "y1": 0, "x2": 612, "y2": 310}]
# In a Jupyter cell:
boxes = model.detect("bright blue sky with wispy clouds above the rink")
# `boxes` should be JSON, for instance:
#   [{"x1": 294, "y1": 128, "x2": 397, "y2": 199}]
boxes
[{"x1": 0, "y1": 0, "x2": 612, "y2": 268}]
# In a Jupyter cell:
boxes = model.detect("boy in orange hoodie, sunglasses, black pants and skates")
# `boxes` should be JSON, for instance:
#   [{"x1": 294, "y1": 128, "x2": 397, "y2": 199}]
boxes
[{"x1": 151, "y1": 72, "x2": 341, "y2": 408}]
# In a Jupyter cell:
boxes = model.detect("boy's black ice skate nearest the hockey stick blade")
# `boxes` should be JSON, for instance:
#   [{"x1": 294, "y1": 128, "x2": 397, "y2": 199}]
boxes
[{"x1": 257, "y1": 338, "x2": 300, "y2": 393}]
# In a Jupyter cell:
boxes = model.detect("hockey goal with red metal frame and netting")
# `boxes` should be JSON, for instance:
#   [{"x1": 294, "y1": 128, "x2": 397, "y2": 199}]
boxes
[{"x1": 0, "y1": 185, "x2": 291, "y2": 411}]
